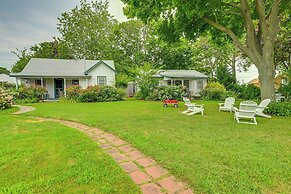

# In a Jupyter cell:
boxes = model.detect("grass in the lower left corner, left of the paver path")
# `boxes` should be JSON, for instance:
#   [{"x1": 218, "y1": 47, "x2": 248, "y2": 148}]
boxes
[{"x1": 0, "y1": 109, "x2": 140, "y2": 193}]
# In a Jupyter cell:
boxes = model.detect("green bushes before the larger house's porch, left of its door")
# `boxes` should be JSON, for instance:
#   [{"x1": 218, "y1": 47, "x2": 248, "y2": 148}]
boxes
[{"x1": 16, "y1": 86, "x2": 47, "y2": 102}]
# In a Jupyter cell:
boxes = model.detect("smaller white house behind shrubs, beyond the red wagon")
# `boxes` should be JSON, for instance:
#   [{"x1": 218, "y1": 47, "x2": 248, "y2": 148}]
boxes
[{"x1": 154, "y1": 70, "x2": 208, "y2": 96}]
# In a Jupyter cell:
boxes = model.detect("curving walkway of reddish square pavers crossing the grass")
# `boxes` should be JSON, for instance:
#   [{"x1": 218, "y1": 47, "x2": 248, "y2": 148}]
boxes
[{"x1": 14, "y1": 106, "x2": 193, "y2": 194}]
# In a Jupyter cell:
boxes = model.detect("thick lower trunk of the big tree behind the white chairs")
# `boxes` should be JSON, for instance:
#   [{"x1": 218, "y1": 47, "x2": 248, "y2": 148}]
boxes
[{"x1": 258, "y1": 61, "x2": 275, "y2": 101}]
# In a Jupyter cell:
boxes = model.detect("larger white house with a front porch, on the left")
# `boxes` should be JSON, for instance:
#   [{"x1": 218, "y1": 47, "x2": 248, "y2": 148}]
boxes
[{"x1": 10, "y1": 58, "x2": 115, "y2": 98}]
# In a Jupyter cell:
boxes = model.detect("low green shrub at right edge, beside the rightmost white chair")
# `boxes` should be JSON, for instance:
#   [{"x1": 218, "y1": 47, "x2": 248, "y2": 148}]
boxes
[{"x1": 265, "y1": 102, "x2": 291, "y2": 116}]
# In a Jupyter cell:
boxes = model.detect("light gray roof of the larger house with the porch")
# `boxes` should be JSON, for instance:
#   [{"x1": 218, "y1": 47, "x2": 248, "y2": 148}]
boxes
[{"x1": 10, "y1": 58, "x2": 115, "y2": 77}]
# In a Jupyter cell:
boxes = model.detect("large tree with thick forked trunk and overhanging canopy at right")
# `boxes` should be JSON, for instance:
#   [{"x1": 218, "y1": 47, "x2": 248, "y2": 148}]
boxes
[{"x1": 122, "y1": 0, "x2": 291, "y2": 99}]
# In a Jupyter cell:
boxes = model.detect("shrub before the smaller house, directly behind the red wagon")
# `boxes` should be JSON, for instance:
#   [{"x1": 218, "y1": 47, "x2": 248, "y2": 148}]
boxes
[{"x1": 158, "y1": 86, "x2": 186, "y2": 100}]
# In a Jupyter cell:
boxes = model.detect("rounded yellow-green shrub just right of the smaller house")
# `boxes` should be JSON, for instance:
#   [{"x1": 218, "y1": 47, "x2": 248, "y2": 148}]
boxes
[{"x1": 200, "y1": 82, "x2": 227, "y2": 100}]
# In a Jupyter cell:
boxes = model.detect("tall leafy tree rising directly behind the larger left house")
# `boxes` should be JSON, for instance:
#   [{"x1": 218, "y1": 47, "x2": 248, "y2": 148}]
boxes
[{"x1": 58, "y1": 0, "x2": 117, "y2": 59}]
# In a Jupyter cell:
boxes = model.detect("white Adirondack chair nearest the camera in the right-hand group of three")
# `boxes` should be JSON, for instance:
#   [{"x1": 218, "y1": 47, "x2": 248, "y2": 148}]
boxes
[{"x1": 233, "y1": 101, "x2": 258, "y2": 125}]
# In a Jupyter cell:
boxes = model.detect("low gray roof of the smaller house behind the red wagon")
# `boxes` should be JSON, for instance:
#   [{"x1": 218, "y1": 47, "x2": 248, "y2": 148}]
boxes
[{"x1": 154, "y1": 70, "x2": 208, "y2": 79}]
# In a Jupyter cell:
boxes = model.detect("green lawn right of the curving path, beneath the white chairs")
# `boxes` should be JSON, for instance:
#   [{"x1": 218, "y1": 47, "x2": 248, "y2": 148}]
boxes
[{"x1": 27, "y1": 101, "x2": 291, "y2": 193}]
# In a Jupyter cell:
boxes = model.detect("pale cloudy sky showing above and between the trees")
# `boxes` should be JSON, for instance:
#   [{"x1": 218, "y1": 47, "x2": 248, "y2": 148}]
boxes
[{"x1": 0, "y1": 0, "x2": 257, "y2": 83}]
